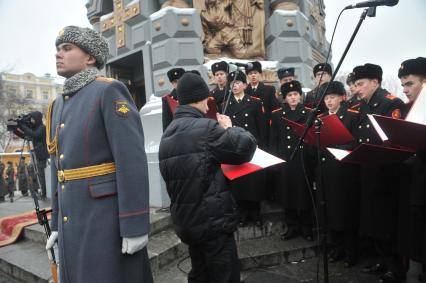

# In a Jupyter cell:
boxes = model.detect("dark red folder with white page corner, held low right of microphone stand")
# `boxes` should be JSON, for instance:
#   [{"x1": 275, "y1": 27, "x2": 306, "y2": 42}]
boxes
[{"x1": 327, "y1": 143, "x2": 414, "y2": 165}]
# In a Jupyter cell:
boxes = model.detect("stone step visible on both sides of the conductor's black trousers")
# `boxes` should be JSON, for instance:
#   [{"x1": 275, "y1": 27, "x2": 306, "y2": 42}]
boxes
[{"x1": 154, "y1": 235, "x2": 317, "y2": 283}]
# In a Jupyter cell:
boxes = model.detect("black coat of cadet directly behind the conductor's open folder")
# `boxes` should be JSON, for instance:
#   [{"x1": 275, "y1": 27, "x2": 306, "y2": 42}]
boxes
[{"x1": 226, "y1": 95, "x2": 266, "y2": 201}]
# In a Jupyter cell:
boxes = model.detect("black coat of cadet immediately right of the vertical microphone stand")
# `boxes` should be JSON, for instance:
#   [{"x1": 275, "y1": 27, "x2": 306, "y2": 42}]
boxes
[{"x1": 316, "y1": 106, "x2": 359, "y2": 231}]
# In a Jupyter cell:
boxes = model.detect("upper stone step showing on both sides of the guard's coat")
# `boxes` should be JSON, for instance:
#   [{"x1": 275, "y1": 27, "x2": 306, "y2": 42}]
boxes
[{"x1": 21, "y1": 208, "x2": 172, "y2": 246}]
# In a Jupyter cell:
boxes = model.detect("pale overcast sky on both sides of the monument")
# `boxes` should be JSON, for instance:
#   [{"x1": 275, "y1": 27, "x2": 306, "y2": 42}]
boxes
[{"x1": 0, "y1": 0, "x2": 426, "y2": 85}]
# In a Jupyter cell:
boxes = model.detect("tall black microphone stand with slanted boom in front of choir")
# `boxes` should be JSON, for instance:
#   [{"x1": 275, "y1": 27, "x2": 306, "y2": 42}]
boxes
[{"x1": 290, "y1": 7, "x2": 376, "y2": 283}]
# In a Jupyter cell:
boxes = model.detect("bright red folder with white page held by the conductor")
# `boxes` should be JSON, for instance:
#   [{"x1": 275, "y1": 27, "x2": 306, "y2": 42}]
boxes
[{"x1": 221, "y1": 148, "x2": 285, "y2": 180}]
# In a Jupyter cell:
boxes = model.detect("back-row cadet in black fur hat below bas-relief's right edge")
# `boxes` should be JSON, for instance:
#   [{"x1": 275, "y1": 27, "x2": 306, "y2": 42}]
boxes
[{"x1": 245, "y1": 61, "x2": 279, "y2": 128}]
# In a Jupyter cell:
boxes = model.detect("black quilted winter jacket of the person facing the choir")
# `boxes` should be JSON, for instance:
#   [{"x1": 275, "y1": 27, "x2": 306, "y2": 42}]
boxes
[{"x1": 159, "y1": 105, "x2": 256, "y2": 244}]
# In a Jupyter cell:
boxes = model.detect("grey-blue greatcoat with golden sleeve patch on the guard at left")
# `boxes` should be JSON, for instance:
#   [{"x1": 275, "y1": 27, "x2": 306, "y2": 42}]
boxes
[{"x1": 51, "y1": 78, "x2": 151, "y2": 283}]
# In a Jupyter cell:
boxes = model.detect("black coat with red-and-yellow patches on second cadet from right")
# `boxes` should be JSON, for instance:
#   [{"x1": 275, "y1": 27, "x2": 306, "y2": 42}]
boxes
[{"x1": 357, "y1": 88, "x2": 404, "y2": 240}]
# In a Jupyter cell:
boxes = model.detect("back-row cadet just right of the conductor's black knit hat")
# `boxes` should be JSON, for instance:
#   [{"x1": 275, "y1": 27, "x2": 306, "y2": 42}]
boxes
[{"x1": 210, "y1": 61, "x2": 229, "y2": 113}]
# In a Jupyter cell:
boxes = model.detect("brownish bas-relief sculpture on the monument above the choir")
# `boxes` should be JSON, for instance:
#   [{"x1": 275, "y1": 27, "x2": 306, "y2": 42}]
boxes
[{"x1": 193, "y1": 0, "x2": 265, "y2": 59}]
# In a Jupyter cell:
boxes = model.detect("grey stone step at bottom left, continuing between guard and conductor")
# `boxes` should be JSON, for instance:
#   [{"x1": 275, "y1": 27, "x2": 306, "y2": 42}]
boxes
[{"x1": 0, "y1": 225, "x2": 187, "y2": 283}]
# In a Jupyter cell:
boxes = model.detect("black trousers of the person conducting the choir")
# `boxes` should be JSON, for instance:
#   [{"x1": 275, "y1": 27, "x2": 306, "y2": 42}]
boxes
[{"x1": 188, "y1": 234, "x2": 240, "y2": 283}]
